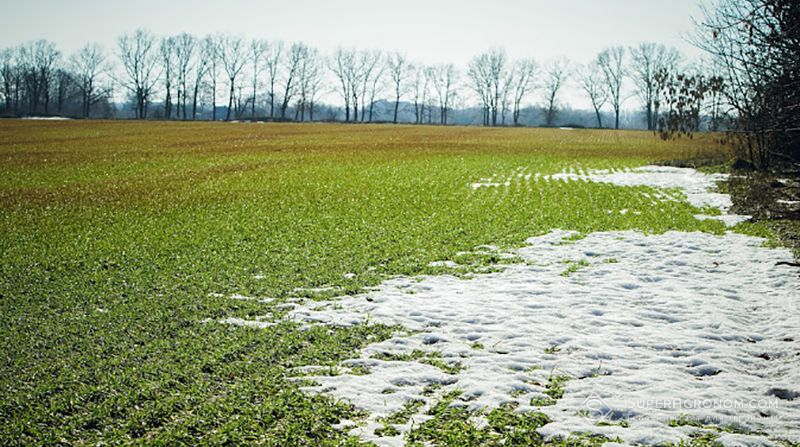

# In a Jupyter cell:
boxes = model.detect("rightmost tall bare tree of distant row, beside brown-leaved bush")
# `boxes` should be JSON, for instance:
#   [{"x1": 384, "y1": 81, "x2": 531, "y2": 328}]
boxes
[{"x1": 629, "y1": 43, "x2": 681, "y2": 130}]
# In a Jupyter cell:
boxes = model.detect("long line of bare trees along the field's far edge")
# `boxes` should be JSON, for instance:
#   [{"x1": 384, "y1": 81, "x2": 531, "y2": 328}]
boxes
[{"x1": 0, "y1": 29, "x2": 724, "y2": 130}]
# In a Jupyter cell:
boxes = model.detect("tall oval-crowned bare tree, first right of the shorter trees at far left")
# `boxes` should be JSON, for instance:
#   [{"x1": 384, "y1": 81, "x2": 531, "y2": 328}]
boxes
[{"x1": 117, "y1": 29, "x2": 158, "y2": 119}]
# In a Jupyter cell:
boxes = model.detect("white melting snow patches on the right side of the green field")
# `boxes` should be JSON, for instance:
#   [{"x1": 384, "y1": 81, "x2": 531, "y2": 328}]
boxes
[{"x1": 216, "y1": 166, "x2": 800, "y2": 445}]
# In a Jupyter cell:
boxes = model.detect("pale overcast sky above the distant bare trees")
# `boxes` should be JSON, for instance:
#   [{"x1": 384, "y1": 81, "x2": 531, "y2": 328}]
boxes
[{"x1": 0, "y1": 0, "x2": 700, "y2": 107}]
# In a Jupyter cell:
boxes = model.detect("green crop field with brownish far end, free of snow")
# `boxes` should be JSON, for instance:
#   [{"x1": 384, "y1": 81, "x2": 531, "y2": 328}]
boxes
[{"x1": 0, "y1": 120, "x2": 760, "y2": 446}]
